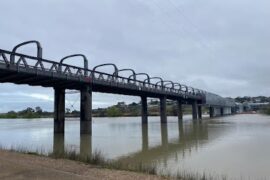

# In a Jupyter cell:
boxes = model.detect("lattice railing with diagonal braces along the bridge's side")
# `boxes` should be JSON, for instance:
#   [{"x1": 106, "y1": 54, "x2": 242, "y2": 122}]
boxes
[{"x1": 0, "y1": 49, "x2": 204, "y2": 98}]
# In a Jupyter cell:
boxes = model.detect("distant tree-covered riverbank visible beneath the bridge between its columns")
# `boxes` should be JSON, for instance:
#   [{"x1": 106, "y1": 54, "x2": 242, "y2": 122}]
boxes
[{"x1": 0, "y1": 101, "x2": 204, "y2": 119}]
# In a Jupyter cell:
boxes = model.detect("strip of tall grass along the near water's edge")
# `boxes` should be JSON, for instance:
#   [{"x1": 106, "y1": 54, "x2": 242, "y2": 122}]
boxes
[{"x1": 0, "y1": 147, "x2": 227, "y2": 180}]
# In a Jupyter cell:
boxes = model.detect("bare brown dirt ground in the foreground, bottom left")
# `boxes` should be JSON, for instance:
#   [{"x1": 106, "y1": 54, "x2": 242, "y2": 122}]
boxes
[{"x1": 0, "y1": 150, "x2": 165, "y2": 180}]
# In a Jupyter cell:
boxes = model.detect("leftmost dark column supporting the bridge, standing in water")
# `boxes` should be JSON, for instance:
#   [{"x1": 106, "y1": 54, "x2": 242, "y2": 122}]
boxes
[{"x1": 54, "y1": 88, "x2": 65, "y2": 134}]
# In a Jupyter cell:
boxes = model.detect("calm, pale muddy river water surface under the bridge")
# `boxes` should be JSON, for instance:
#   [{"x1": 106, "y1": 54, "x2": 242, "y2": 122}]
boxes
[{"x1": 0, "y1": 115, "x2": 270, "y2": 179}]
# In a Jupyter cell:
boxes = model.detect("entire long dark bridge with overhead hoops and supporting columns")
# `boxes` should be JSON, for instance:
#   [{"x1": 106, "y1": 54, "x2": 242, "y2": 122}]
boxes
[{"x1": 0, "y1": 41, "x2": 235, "y2": 134}]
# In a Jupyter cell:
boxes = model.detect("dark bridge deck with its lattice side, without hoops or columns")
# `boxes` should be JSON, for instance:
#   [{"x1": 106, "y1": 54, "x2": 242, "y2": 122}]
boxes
[{"x1": 0, "y1": 49, "x2": 203, "y2": 102}]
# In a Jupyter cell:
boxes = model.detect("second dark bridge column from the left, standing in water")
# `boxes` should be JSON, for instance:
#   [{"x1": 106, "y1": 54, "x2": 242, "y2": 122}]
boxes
[{"x1": 80, "y1": 86, "x2": 92, "y2": 134}]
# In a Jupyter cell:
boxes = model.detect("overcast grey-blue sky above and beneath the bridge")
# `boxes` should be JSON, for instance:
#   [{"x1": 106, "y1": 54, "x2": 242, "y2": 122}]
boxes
[{"x1": 0, "y1": 0, "x2": 270, "y2": 112}]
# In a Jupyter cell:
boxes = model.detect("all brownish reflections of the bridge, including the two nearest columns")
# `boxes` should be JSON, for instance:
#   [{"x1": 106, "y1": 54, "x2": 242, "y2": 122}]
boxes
[{"x1": 53, "y1": 120, "x2": 232, "y2": 163}]
